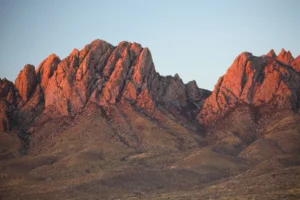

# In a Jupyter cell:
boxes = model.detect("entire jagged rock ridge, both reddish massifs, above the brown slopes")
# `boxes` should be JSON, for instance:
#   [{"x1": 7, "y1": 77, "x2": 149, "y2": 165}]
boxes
[{"x1": 1, "y1": 40, "x2": 300, "y2": 134}]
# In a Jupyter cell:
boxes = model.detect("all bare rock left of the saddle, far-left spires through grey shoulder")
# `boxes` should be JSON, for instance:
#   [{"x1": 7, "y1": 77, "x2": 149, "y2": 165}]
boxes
[{"x1": 2, "y1": 40, "x2": 210, "y2": 132}]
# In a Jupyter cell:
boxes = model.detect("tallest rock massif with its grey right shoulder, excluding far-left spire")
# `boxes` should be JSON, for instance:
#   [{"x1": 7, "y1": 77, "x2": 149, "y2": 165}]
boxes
[{"x1": 37, "y1": 40, "x2": 209, "y2": 119}]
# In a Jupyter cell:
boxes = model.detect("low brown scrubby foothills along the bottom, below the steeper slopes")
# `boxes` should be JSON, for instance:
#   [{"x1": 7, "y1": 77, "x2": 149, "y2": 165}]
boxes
[{"x1": 0, "y1": 144, "x2": 300, "y2": 200}]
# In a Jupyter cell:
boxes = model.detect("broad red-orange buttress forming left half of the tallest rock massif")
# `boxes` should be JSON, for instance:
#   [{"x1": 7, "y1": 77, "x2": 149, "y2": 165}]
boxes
[{"x1": 45, "y1": 40, "x2": 113, "y2": 115}]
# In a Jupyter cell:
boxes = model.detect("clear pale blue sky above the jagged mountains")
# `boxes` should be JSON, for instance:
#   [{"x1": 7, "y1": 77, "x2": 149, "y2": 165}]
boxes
[{"x1": 0, "y1": 0, "x2": 300, "y2": 90}]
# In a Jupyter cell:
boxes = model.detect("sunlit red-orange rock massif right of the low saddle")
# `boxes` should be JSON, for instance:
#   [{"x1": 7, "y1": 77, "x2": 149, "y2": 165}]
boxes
[{"x1": 198, "y1": 49, "x2": 300, "y2": 125}]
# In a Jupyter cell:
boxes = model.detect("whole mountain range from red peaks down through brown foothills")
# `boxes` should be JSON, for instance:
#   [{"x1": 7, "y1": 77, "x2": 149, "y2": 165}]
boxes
[{"x1": 0, "y1": 40, "x2": 300, "y2": 200}]
